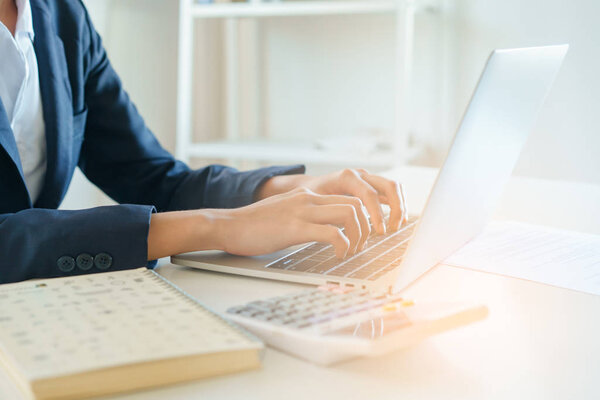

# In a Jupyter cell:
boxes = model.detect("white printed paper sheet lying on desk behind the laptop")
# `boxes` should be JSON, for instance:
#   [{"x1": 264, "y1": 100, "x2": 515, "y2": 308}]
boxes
[{"x1": 443, "y1": 222, "x2": 600, "y2": 294}]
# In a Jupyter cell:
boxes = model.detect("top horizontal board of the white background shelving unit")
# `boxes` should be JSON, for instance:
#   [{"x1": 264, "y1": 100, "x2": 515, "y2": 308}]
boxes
[{"x1": 192, "y1": 0, "x2": 399, "y2": 18}]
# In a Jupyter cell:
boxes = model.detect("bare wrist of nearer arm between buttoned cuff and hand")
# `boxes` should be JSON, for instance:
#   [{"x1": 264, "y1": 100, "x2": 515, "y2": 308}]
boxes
[{"x1": 148, "y1": 210, "x2": 225, "y2": 260}]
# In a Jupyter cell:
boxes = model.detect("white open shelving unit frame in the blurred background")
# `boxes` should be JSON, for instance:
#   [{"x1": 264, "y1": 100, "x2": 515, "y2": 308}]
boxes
[{"x1": 176, "y1": 0, "x2": 422, "y2": 168}]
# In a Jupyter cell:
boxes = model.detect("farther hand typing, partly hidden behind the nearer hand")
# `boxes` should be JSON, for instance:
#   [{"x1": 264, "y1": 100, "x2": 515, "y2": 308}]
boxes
[{"x1": 257, "y1": 169, "x2": 408, "y2": 234}]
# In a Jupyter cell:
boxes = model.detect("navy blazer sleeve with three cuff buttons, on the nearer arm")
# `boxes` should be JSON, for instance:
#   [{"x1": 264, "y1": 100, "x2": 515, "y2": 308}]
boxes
[{"x1": 0, "y1": 205, "x2": 154, "y2": 283}]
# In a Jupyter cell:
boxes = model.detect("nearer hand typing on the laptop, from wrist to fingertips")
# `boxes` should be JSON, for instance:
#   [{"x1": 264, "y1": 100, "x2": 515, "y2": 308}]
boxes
[{"x1": 215, "y1": 188, "x2": 371, "y2": 258}]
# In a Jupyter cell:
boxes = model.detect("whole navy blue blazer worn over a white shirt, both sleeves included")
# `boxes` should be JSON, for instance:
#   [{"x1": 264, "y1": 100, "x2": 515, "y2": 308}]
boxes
[{"x1": 0, "y1": 0, "x2": 304, "y2": 283}]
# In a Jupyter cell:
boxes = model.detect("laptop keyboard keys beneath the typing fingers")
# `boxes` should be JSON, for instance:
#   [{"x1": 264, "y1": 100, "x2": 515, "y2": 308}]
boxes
[{"x1": 266, "y1": 217, "x2": 417, "y2": 280}]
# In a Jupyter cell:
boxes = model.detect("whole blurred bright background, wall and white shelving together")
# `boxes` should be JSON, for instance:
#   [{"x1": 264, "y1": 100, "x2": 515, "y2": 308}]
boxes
[{"x1": 63, "y1": 0, "x2": 600, "y2": 208}]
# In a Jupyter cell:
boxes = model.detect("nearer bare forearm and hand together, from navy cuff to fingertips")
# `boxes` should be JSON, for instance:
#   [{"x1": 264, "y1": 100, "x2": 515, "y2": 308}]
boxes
[{"x1": 148, "y1": 188, "x2": 371, "y2": 260}]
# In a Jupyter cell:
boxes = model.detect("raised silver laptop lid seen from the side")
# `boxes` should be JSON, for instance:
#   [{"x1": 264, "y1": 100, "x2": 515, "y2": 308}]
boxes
[{"x1": 386, "y1": 45, "x2": 568, "y2": 291}]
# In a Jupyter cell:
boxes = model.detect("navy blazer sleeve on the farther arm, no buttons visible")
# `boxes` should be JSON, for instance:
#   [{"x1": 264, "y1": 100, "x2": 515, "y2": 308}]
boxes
[{"x1": 79, "y1": 7, "x2": 304, "y2": 211}]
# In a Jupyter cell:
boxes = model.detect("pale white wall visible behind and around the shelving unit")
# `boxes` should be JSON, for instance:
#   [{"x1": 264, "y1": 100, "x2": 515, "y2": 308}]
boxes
[{"x1": 67, "y1": 0, "x2": 600, "y2": 211}]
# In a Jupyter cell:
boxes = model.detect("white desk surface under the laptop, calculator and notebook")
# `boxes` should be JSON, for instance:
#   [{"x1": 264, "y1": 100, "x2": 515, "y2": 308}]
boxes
[{"x1": 115, "y1": 168, "x2": 600, "y2": 400}]
